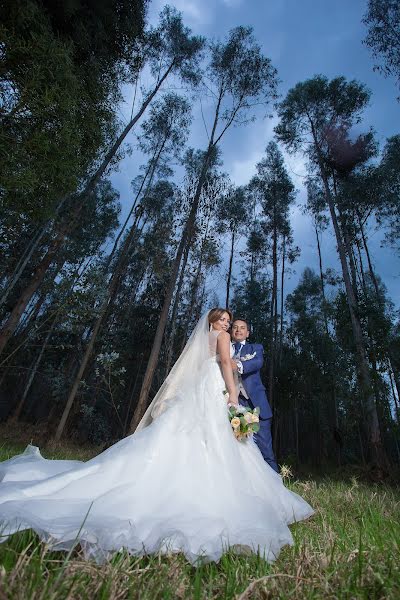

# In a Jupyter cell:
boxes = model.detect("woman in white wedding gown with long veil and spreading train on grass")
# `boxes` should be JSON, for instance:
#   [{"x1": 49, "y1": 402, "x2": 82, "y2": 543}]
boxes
[{"x1": 0, "y1": 308, "x2": 313, "y2": 564}]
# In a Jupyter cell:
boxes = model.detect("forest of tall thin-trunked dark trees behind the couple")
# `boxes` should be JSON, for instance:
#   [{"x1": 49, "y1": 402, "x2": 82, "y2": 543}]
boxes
[{"x1": 0, "y1": 0, "x2": 400, "y2": 476}]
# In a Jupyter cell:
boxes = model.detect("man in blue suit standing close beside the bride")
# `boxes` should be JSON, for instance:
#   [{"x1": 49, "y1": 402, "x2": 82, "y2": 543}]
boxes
[{"x1": 231, "y1": 319, "x2": 279, "y2": 473}]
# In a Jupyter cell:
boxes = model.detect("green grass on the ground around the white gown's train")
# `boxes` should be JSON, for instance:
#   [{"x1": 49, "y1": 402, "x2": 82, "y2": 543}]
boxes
[{"x1": 0, "y1": 443, "x2": 400, "y2": 600}]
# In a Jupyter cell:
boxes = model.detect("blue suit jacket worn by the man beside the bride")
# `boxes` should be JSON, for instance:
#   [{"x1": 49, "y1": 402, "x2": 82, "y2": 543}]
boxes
[{"x1": 240, "y1": 344, "x2": 272, "y2": 419}]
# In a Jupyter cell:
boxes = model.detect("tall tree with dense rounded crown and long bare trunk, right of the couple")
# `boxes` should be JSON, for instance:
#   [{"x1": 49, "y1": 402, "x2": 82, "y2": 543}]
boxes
[{"x1": 276, "y1": 76, "x2": 384, "y2": 466}]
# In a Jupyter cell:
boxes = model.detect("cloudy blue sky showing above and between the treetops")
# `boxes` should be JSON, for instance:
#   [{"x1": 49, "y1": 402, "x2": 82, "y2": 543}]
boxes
[{"x1": 112, "y1": 0, "x2": 400, "y2": 304}]
